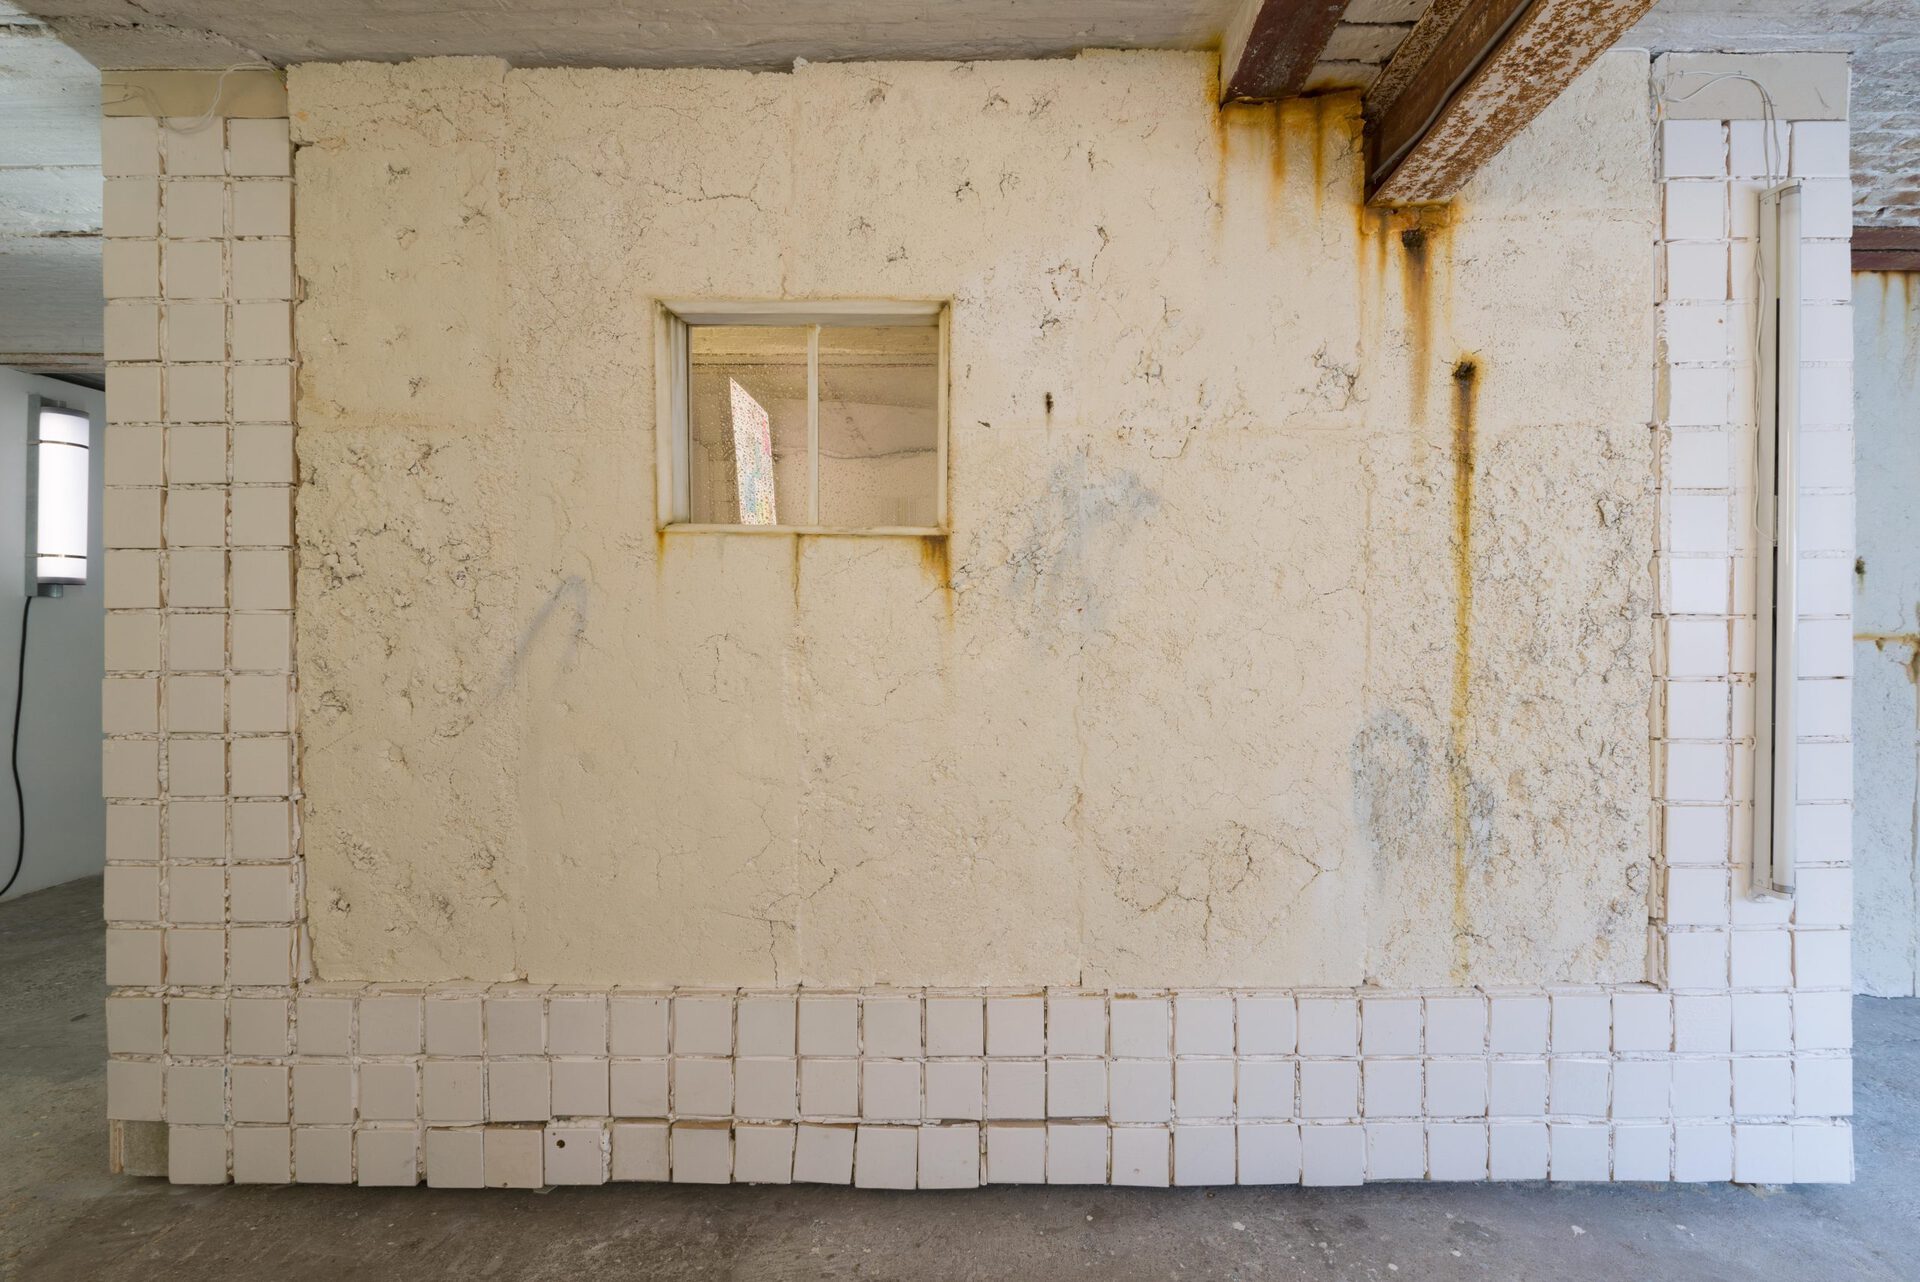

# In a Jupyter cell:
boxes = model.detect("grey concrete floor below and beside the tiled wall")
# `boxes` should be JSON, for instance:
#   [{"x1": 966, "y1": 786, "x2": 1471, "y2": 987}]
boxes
[{"x1": 0, "y1": 881, "x2": 1920, "y2": 1282}]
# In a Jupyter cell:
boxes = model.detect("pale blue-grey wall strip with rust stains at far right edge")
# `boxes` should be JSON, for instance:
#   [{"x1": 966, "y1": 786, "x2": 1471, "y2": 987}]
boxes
[{"x1": 1853, "y1": 273, "x2": 1920, "y2": 996}]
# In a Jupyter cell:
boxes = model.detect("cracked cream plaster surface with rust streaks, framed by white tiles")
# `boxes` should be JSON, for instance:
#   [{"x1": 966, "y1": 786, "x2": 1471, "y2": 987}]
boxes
[{"x1": 290, "y1": 54, "x2": 1655, "y2": 986}]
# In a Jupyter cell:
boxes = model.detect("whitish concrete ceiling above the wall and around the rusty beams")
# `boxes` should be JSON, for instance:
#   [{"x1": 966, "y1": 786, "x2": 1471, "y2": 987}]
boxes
[{"x1": 0, "y1": 0, "x2": 1920, "y2": 367}]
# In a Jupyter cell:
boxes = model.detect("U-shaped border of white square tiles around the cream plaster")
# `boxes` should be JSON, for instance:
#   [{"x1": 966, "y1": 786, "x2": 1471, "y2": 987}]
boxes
[{"x1": 106, "y1": 57, "x2": 1851, "y2": 1188}]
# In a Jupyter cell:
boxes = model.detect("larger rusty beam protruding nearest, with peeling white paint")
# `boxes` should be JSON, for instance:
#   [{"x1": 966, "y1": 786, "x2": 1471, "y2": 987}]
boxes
[{"x1": 1367, "y1": 0, "x2": 1653, "y2": 205}]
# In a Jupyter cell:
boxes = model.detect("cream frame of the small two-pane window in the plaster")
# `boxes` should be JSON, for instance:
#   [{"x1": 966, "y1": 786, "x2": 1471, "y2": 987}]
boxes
[{"x1": 653, "y1": 299, "x2": 952, "y2": 537}]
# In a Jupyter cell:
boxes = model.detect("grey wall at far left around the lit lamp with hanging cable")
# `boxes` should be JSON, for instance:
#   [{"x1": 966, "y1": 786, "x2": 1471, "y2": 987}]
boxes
[{"x1": 0, "y1": 367, "x2": 108, "y2": 898}]
